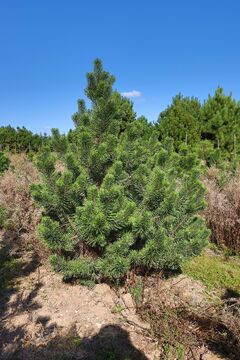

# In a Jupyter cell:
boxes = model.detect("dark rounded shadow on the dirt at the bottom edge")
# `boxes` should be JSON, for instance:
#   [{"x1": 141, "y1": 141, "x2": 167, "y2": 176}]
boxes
[{"x1": 12, "y1": 319, "x2": 147, "y2": 360}]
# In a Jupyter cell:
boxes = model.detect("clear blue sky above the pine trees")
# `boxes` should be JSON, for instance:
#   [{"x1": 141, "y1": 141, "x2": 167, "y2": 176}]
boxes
[{"x1": 0, "y1": 0, "x2": 240, "y2": 132}]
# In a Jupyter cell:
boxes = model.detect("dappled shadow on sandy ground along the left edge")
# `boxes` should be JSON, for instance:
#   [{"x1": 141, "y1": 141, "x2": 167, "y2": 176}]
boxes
[{"x1": 0, "y1": 238, "x2": 42, "y2": 359}]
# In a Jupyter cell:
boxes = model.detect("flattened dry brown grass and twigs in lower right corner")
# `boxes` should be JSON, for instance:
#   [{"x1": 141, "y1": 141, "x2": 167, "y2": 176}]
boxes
[{"x1": 138, "y1": 279, "x2": 240, "y2": 360}]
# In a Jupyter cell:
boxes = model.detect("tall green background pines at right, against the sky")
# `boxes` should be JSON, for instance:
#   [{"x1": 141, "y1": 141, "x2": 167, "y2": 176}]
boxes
[{"x1": 157, "y1": 87, "x2": 240, "y2": 166}]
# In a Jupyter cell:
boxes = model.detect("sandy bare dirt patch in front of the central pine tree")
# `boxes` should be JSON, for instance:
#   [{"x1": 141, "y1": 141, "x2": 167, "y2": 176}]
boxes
[{"x1": 0, "y1": 255, "x2": 157, "y2": 360}]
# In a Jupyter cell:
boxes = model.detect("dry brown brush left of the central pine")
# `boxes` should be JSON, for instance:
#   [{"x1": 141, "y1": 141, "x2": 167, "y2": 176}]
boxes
[{"x1": 0, "y1": 154, "x2": 45, "y2": 255}]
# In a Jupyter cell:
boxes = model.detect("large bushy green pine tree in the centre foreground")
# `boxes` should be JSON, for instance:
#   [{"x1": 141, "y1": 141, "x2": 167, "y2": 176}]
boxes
[{"x1": 32, "y1": 60, "x2": 209, "y2": 282}]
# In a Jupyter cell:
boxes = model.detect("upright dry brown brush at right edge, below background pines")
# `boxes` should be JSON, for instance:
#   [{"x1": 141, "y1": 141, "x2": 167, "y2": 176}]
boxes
[{"x1": 204, "y1": 168, "x2": 240, "y2": 251}]
